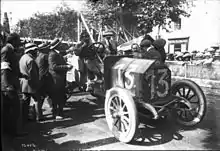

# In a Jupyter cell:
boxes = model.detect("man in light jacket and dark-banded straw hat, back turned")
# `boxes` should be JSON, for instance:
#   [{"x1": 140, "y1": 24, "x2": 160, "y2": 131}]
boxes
[{"x1": 19, "y1": 43, "x2": 42, "y2": 122}]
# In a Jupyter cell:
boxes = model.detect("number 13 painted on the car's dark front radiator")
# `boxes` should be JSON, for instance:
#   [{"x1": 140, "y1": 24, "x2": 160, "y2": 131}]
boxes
[{"x1": 145, "y1": 69, "x2": 169, "y2": 99}]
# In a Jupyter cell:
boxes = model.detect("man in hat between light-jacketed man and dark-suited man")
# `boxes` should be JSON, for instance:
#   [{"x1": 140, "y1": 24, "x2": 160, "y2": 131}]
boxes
[{"x1": 35, "y1": 43, "x2": 52, "y2": 118}]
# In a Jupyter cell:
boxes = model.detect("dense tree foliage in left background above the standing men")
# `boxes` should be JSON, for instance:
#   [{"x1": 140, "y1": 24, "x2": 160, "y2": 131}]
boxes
[{"x1": 14, "y1": 3, "x2": 77, "y2": 40}]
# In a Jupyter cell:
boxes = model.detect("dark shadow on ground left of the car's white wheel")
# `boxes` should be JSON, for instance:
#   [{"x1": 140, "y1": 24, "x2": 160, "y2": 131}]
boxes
[{"x1": 5, "y1": 94, "x2": 116, "y2": 151}]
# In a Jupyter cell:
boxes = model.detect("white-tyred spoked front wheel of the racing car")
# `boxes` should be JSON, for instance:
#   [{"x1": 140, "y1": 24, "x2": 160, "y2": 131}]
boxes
[{"x1": 105, "y1": 88, "x2": 138, "y2": 143}]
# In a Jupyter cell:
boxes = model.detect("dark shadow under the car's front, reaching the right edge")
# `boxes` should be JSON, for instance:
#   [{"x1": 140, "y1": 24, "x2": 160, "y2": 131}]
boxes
[{"x1": 132, "y1": 94, "x2": 220, "y2": 150}]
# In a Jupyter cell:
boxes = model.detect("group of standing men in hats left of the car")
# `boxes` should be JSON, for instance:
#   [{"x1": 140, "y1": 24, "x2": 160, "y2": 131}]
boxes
[{"x1": 1, "y1": 33, "x2": 75, "y2": 135}]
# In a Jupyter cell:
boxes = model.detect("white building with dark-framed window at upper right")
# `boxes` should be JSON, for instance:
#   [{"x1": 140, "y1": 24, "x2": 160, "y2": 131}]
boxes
[{"x1": 152, "y1": 0, "x2": 220, "y2": 53}]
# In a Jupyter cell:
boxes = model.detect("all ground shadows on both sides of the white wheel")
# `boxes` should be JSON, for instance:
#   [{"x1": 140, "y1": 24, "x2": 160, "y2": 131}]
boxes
[{"x1": 3, "y1": 92, "x2": 220, "y2": 151}]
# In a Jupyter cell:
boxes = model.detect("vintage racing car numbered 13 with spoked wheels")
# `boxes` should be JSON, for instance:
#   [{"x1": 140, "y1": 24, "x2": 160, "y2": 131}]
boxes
[{"x1": 69, "y1": 43, "x2": 207, "y2": 143}]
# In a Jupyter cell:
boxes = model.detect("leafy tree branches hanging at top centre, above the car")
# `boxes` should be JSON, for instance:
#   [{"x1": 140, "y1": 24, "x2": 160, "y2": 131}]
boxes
[{"x1": 84, "y1": 0, "x2": 189, "y2": 33}]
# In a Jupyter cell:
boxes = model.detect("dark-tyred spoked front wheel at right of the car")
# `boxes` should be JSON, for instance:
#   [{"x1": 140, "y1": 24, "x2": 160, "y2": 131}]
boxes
[{"x1": 172, "y1": 80, "x2": 207, "y2": 126}]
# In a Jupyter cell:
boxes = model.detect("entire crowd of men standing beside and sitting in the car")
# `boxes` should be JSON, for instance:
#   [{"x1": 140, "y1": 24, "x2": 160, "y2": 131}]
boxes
[{"x1": 1, "y1": 28, "x2": 166, "y2": 135}]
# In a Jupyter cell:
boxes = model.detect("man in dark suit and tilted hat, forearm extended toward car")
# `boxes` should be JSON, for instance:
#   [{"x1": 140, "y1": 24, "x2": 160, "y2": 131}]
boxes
[{"x1": 48, "y1": 38, "x2": 72, "y2": 120}]
